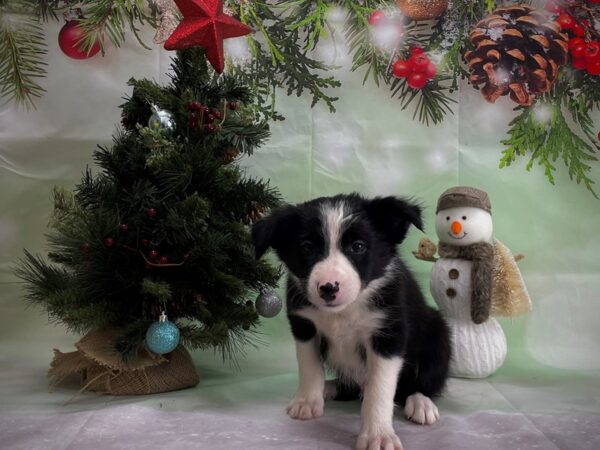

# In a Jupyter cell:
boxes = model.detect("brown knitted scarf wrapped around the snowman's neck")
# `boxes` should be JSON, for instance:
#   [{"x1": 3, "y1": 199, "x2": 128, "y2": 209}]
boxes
[{"x1": 438, "y1": 242, "x2": 494, "y2": 323}]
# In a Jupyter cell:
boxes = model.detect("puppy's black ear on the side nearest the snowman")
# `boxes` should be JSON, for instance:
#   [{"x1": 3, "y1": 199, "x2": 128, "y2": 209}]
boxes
[{"x1": 366, "y1": 197, "x2": 423, "y2": 244}]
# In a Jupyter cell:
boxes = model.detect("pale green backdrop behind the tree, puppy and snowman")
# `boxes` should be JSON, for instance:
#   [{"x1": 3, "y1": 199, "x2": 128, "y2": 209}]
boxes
[{"x1": 0, "y1": 24, "x2": 600, "y2": 450}]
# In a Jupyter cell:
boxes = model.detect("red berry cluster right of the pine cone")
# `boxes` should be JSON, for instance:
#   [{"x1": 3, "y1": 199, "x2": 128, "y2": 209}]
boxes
[{"x1": 546, "y1": 5, "x2": 600, "y2": 75}]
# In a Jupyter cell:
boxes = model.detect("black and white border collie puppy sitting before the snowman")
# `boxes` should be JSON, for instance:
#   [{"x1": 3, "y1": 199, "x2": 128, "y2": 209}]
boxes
[{"x1": 252, "y1": 194, "x2": 450, "y2": 450}]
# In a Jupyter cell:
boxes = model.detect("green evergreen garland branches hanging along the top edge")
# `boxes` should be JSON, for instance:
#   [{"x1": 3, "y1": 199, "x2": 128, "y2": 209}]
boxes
[{"x1": 0, "y1": 0, "x2": 600, "y2": 195}]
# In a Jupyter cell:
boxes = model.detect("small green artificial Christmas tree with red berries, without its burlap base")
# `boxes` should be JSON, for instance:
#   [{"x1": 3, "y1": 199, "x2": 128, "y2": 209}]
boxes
[{"x1": 17, "y1": 48, "x2": 279, "y2": 394}]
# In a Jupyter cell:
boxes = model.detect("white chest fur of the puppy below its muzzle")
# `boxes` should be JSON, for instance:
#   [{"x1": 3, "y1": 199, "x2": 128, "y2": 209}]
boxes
[{"x1": 300, "y1": 305, "x2": 382, "y2": 385}]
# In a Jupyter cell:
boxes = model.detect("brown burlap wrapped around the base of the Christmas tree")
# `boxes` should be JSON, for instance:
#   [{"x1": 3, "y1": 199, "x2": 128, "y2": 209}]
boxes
[{"x1": 48, "y1": 330, "x2": 199, "y2": 395}]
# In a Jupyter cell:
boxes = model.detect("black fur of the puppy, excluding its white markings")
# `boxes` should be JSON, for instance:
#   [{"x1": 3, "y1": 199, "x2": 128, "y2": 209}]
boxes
[{"x1": 252, "y1": 194, "x2": 450, "y2": 403}]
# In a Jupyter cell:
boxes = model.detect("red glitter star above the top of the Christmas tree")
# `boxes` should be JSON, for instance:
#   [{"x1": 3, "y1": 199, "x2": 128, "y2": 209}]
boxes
[{"x1": 165, "y1": 0, "x2": 252, "y2": 73}]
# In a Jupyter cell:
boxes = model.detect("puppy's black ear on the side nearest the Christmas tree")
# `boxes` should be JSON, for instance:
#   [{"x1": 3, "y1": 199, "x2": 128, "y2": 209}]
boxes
[{"x1": 252, "y1": 206, "x2": 300, "y2": 259}]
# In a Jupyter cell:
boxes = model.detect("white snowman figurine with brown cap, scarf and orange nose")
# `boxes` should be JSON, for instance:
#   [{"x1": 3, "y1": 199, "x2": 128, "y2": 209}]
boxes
[{"x1": 430, "y1": 186, "x2": 507, "y2": 378}]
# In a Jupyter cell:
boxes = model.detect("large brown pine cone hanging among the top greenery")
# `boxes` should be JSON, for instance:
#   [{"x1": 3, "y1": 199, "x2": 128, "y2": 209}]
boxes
[{"x1": 465, "y1": 5, "x2": 569, "y2": 105}]
